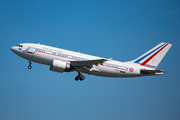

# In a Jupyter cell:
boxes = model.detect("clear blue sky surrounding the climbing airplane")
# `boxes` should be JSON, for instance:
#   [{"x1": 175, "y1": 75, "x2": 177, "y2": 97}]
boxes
[{"x1": 0, "y1": 0, "x2": 180, "y2": 120}]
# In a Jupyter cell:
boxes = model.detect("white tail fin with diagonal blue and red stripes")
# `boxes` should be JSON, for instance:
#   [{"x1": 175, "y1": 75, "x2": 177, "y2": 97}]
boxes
[{"x1": 131, "y1": 42, "x2": 172, "y2": 69}]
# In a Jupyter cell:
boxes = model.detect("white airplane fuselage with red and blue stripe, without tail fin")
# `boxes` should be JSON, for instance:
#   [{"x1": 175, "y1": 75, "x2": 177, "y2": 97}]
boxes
[{"x1": 11, "y1": 43, "x2": 158, "y2": 77}]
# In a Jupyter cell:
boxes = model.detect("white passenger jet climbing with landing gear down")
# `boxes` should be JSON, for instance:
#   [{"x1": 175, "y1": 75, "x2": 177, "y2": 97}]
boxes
[{"x1": 11, "y1": 42, "x2": 172, "y2": 81}]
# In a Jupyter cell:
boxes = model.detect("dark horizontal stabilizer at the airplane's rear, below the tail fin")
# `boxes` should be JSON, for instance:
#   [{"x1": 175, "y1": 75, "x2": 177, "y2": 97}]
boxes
[{"x1": 141, "y1": 70, "x2": 166, "y2": 75}]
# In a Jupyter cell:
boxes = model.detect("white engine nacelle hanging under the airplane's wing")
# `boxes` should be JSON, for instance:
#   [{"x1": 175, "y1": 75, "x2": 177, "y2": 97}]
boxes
[{"x1": 50, "y1": 60, "x2": 71, "y2": 73}]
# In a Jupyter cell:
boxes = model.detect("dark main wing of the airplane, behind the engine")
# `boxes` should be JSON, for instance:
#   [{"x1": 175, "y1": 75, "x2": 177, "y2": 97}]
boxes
[{"x1": 71, "y1": 59, "x2": 108, "y2": 68}]
